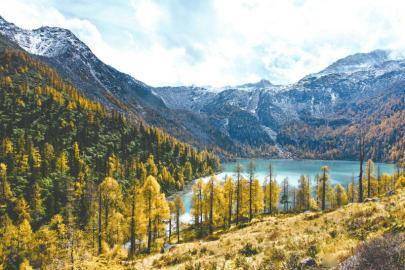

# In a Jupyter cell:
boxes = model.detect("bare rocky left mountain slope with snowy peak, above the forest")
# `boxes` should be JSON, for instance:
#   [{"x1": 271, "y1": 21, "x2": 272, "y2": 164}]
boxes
[{"x1": 0, "y1": 17, "x2": 251, "y2": 158}]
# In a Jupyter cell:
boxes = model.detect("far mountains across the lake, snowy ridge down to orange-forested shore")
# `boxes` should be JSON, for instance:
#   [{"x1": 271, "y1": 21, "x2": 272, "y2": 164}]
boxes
[{"x1": 155, "y1": 50, "x2": 405, "y2": 160}]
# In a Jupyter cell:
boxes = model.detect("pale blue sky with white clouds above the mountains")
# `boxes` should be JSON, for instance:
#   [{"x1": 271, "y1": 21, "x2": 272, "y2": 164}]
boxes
[{"x1": 0, "y1": 0, "x2": 405, "y2": 87}]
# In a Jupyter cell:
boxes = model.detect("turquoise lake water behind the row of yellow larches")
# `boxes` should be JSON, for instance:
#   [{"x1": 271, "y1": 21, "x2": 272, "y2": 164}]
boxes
[{"x1": 182, "y1": 159, "x2": 395, "y2": 222}]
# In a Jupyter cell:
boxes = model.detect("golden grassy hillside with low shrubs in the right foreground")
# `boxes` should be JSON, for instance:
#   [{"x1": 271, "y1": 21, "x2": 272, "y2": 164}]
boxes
[{"x1": 128, "y1": 189, "x2": 405, "y2": 269}]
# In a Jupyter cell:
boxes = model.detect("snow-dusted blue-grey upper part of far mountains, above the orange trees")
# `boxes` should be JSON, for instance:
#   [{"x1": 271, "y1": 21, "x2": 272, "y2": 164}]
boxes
[{"x1": 155, "y1": 50, "x2": 405, "y2": 155}]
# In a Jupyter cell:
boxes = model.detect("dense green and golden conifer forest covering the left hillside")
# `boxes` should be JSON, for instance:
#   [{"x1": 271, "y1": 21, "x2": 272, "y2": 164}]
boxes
[{"x1": 0, "y1": 37, "x2": 220, "y2": 269}]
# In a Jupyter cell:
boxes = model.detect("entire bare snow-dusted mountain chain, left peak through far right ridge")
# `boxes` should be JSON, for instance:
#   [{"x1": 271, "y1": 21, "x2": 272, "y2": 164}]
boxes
[{"x1": 0, "y1": 17, "x2": 405, "y2": 159}]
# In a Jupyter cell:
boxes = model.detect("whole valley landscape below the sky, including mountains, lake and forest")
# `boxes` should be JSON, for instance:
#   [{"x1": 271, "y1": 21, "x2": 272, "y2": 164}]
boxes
[{"x1": 0, "y1": 11, "x2": 405, "y2": 270}]
